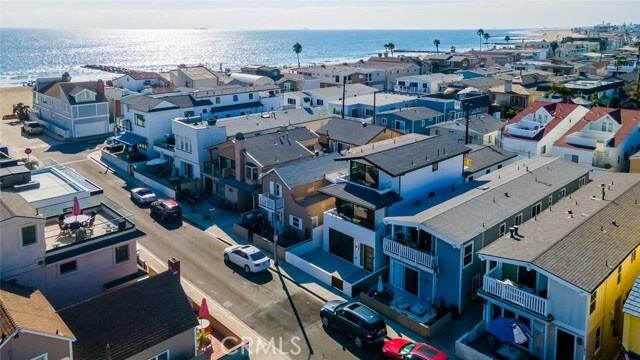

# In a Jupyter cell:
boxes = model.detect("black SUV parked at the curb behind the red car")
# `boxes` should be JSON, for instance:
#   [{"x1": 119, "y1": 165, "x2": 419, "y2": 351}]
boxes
[{"x1": 320, "y1": 300, "x2": 387, "y2": 347}]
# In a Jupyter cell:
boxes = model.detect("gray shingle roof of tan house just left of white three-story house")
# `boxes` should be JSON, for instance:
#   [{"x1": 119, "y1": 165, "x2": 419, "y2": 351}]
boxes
[{"x1": 275, "y1": 152, "x2": 349, "y2": 189}]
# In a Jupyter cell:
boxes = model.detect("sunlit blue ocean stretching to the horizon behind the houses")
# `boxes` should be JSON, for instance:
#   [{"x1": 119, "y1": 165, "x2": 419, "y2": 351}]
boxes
[{"x1": 0, "y1": 28, "x2": 531, "y2": 87}]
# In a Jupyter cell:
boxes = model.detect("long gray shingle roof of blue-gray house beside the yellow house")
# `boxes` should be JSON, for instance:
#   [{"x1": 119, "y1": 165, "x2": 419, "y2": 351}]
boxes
[{"x1": 385, "y1": 157, "x2": 589, "y2": 244}]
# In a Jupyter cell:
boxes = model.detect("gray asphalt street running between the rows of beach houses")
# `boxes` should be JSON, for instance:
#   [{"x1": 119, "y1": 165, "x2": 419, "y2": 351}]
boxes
[{"x1": 33, "y1": 140, "x2": 380, "y2": 359}]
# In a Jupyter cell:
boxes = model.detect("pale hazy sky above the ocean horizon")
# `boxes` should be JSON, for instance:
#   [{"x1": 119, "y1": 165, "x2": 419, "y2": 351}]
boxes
[{"x1": 0, "y1": 0, "x2": 640, "y2": 30}]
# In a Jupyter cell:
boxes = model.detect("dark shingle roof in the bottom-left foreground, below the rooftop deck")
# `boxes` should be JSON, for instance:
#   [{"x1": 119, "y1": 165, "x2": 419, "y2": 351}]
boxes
[{"x1": 58, "y1": 271, "x2": 198, "y2": 360}]
